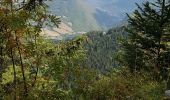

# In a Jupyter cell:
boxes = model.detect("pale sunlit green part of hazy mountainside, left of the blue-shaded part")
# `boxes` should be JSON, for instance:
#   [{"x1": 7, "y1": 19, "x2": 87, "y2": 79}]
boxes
[{"x1": 49, "y1": 0, "x2": 100, "y2": 31}]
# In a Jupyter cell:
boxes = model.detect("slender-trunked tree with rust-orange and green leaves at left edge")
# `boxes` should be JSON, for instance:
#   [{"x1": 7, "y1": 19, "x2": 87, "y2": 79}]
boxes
[{"x1": 0, "y1": 0, "x2": 59, "y2": 99}]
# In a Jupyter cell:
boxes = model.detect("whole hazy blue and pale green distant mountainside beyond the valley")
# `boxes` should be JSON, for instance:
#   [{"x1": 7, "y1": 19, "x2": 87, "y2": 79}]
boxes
[{"x1": 48, "y1": 0, "x2": 146, "y2": 32}]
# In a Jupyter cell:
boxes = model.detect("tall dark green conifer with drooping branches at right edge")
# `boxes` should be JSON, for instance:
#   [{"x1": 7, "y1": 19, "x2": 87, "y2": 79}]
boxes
[{"x1": 124, "y1": 0, "x2": 170, "y2": 79}]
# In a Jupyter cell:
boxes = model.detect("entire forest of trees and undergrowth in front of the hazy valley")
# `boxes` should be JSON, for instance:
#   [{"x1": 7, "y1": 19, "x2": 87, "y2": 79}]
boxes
[{"x1": 0, "y1": 0, "x2": 170, "y2": 100}]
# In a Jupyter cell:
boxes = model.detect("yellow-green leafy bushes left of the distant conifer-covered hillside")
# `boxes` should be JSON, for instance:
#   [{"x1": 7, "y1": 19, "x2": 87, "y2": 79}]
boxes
[{"x1": 45, "y1": 37, "x2": 98, "y2": 98}]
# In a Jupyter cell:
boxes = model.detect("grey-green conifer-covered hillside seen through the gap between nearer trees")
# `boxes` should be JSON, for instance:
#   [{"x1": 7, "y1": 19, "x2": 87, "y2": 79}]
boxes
[{"x1": 85, "y1": 27, "x2": 127, "y2": 73}]
